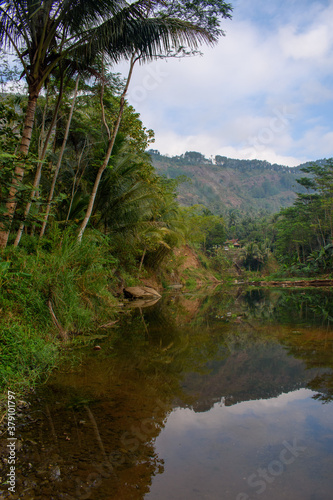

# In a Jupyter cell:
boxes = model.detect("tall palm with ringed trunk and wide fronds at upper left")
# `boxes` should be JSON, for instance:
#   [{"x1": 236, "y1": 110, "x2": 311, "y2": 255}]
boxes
[{"x1": 0, "y1": 0, "x2": 216, "y2": 247}]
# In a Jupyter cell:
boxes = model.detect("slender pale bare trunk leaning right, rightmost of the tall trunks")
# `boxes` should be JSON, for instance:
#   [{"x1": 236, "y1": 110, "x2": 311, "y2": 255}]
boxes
[{"x1": 78, "y1": 54, "x2": 138, "y2": 241}]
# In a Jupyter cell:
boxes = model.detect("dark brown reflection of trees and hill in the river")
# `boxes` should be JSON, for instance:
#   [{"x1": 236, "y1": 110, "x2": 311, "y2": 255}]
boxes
[{"x1": 12, "y1": 288, "x2": 333, "y2": 499}]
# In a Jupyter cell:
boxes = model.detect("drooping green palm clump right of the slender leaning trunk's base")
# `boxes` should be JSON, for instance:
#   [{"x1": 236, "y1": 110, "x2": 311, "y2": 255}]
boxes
[{"x1": 82, "y1": 134, "x2": 185, "y2": 275}]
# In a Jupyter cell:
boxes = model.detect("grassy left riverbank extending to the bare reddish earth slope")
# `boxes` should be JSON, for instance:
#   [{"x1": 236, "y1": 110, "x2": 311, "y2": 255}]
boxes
[{"x1": 0, "y1": 233, "x2": 223, "y2": 406}]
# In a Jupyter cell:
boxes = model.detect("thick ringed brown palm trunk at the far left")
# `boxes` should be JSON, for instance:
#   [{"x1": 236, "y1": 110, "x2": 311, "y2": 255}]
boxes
[{"x1": 0, "y1": 88, "x2": 39, "y2": 248}]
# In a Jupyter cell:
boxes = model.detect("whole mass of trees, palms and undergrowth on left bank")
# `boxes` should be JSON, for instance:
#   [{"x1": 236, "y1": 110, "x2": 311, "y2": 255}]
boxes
[{"x1": 0, "y1": 0, "x2": 232, "y2": 396}]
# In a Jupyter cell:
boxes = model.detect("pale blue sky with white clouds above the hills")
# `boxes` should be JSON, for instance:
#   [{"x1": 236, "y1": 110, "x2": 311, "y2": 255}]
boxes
[{"x1": 118, "y1": 0, "x2": 333, "y2": 166}]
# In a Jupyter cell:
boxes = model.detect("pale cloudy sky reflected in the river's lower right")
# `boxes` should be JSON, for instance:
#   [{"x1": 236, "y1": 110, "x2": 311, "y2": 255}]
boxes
[{"x1": 145, "y1": 389, "x2": 333, "y2": 500}]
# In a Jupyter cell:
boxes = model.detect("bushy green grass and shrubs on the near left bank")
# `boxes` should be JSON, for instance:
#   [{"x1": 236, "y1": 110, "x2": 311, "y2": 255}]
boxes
[{"x1": 0, "y1": 228, "x2": 118, "y2": 400}]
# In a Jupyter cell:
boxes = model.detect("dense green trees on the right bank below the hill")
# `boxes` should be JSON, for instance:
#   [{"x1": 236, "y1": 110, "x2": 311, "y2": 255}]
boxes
[{"x1": 214, "y1": 159, "x2": 333, "y2": 276}]
